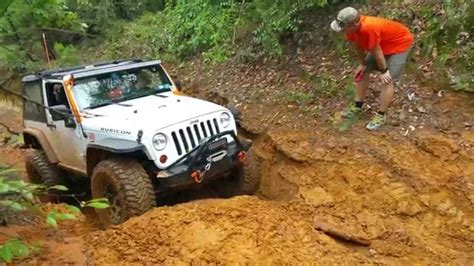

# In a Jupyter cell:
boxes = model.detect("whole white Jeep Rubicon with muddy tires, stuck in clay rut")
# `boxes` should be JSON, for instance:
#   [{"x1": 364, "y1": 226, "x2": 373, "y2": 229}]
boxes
[{"x1": 22, "y1": 60, "x2": 260, "y2": 224}]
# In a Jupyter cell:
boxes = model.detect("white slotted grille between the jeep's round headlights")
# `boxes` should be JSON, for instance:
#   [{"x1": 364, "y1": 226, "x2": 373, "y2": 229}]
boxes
[{"x1": 171, "y1": 118, "x2": 220, "y2": 155}]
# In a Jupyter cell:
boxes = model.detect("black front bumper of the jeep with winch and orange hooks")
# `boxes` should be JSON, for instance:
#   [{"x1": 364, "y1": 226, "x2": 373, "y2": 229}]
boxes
[{"x1": 157, "y1": 130, "x2": 252, "y2": 192}]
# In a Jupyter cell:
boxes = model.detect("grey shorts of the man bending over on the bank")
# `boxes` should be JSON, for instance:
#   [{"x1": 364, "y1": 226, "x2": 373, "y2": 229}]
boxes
[{"x1": 365, "y1": 49, "x2": 411, "y2": 81}]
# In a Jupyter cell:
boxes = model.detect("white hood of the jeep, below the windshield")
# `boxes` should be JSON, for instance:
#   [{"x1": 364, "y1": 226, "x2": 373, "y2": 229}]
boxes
[{"x1": 83, "y1": 92, "x2": 227, "y2": 133}]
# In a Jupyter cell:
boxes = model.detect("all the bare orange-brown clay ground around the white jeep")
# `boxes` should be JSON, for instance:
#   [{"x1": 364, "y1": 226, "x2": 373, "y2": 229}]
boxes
[{"x1": 0, "y1": 71, "x2": 474, "y2": 265}]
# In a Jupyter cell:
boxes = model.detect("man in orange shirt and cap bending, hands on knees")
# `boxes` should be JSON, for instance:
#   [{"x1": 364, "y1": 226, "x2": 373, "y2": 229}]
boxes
[{"x1": 331, "y1": 7, "x2": 414, "y2": 130}]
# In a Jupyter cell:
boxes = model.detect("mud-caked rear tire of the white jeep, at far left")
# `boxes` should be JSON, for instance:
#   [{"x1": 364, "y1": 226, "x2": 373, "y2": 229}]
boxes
[{"x1": 25, "y1": 149, "x2": 65, "y2": 197}]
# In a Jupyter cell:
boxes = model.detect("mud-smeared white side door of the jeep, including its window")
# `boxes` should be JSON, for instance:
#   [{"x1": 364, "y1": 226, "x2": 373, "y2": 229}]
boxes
[{"x1": 43, "y1": 80, "x2": 87, "y2": 174}]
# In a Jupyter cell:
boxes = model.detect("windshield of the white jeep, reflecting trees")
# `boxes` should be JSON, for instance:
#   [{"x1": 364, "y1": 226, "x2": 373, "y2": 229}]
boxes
[{"x1": 72, "y1": 66, "x2": 171, "y2": 110}]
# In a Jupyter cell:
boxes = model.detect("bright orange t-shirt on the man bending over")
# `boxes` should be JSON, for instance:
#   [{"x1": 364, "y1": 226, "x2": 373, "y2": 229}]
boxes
[{"x1": 346, "y1": 16, "x2": 414, "y2": 55}]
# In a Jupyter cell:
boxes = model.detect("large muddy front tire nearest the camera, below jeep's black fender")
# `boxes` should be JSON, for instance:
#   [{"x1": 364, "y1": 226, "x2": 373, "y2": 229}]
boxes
[{"x1": 91, "y1": 159, "x2": 156, "y2": 226}]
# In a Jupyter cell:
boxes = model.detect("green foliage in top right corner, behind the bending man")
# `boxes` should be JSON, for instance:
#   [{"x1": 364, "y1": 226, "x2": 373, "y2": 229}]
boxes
[{"x1": 382, "y1": 0, "x2": 474, "y2": 92}]
